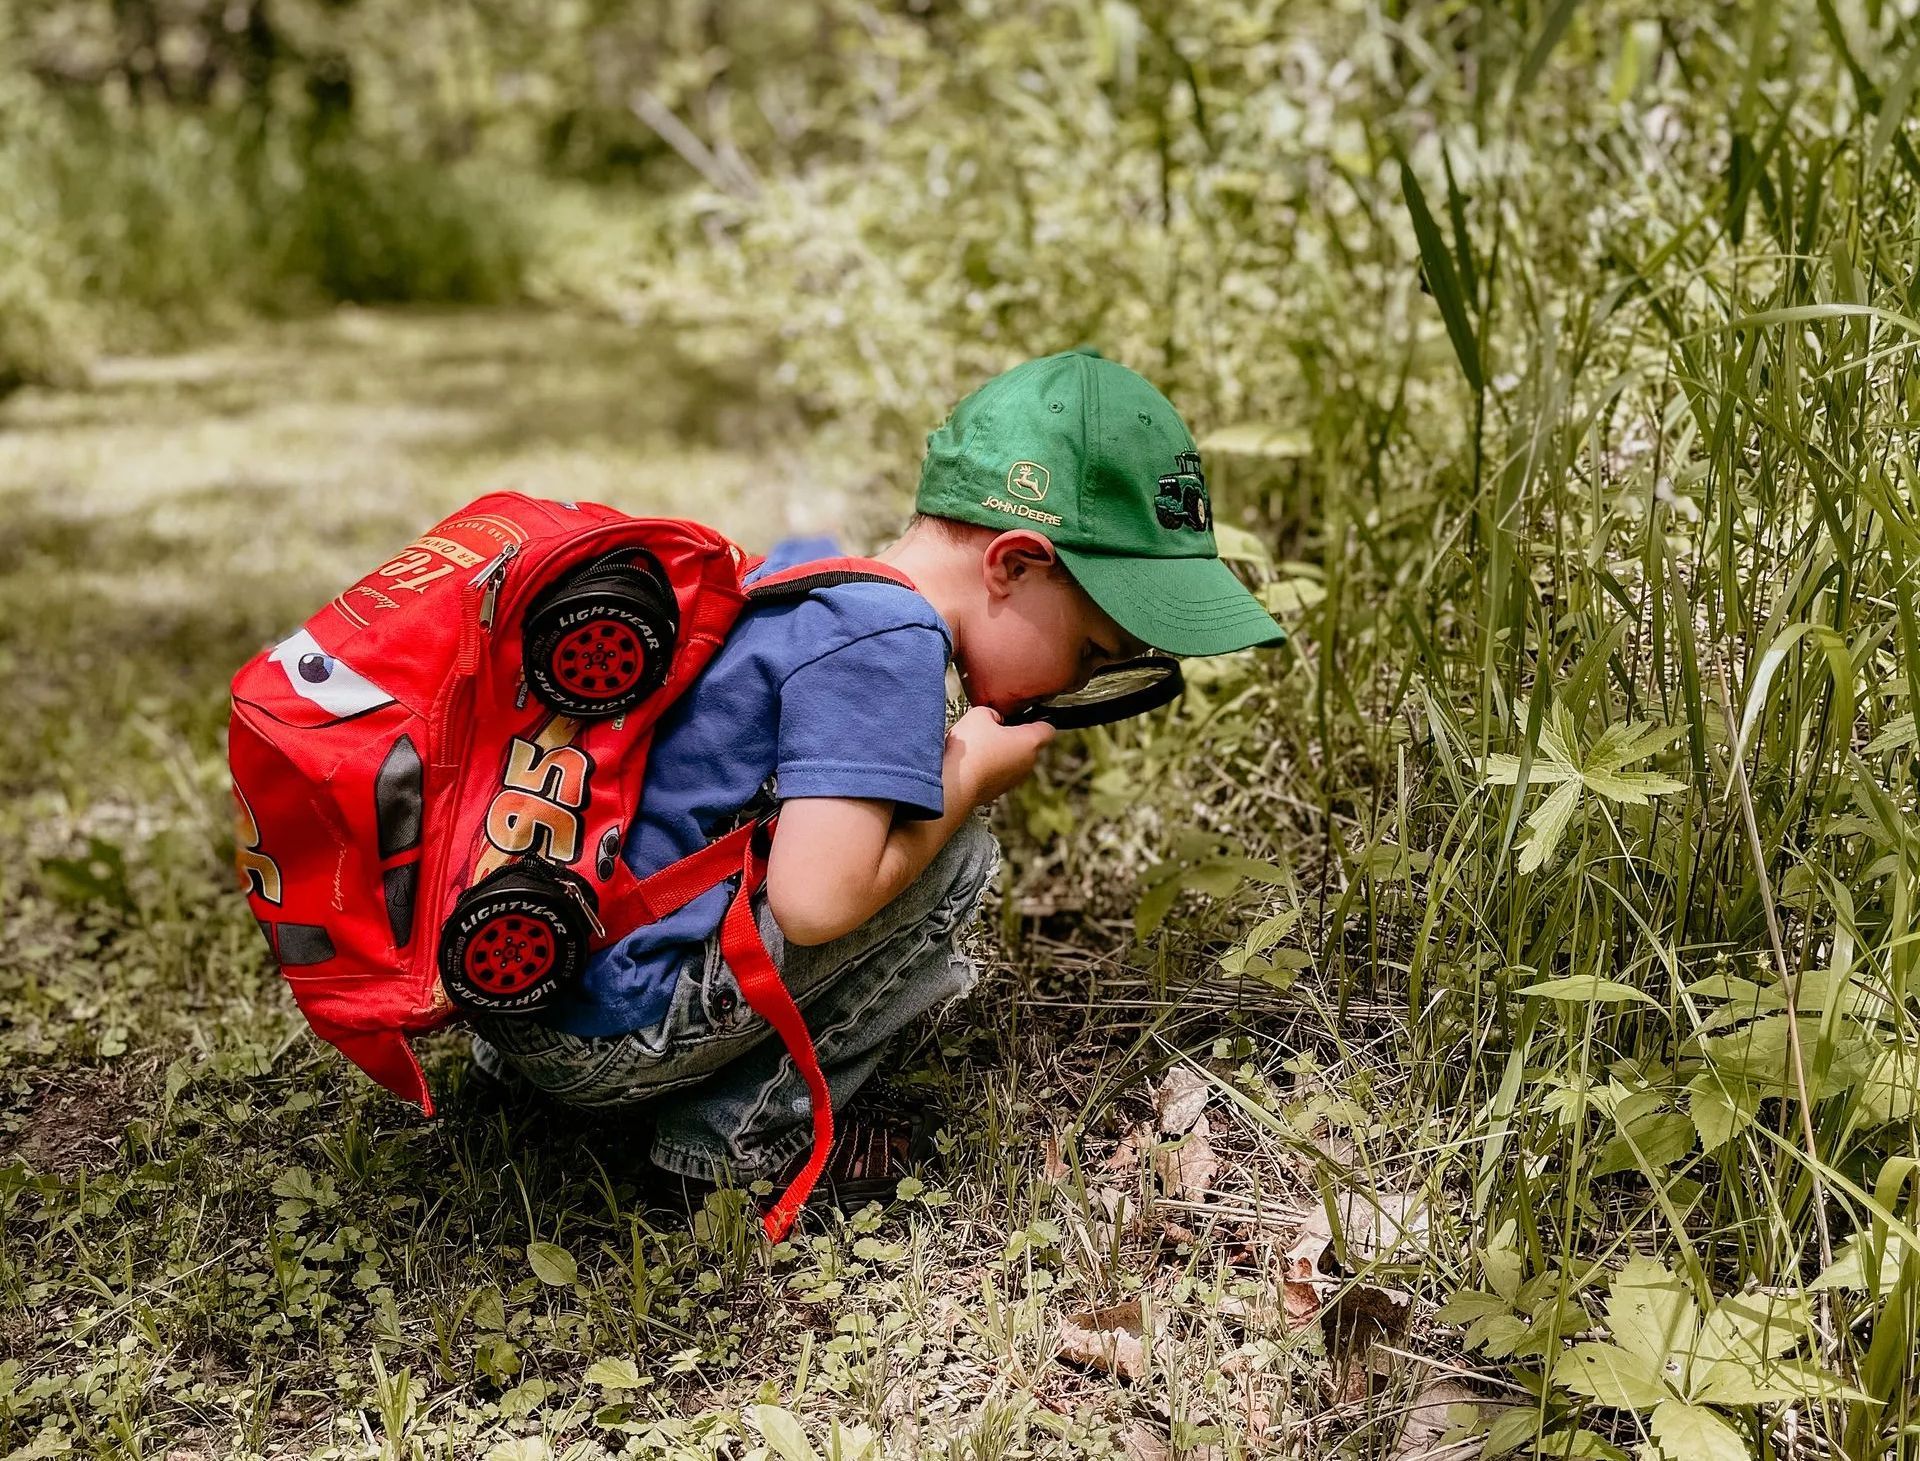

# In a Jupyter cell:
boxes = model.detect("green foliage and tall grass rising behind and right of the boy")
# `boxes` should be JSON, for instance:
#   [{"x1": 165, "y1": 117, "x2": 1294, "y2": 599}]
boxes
[{"x1": 11, "y1": 0, "x2": 1920, "y2": 1461}]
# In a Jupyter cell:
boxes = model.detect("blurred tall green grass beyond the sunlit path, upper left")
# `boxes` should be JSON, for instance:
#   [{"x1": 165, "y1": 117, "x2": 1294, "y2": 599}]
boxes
[{"x1": 0, "y1": 100, "x2": 541, "y2": 395}]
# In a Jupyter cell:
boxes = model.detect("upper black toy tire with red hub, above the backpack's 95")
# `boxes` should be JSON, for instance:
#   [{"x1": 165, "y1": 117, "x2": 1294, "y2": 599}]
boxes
[{"x1": 520, "y1": 551, "x2": 678, "y2": 720}]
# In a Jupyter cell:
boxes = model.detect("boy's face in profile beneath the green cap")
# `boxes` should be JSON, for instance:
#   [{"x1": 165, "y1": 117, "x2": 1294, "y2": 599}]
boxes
[{"x1": 958, "y1": 530, "x2": 1146, "y2": 714}]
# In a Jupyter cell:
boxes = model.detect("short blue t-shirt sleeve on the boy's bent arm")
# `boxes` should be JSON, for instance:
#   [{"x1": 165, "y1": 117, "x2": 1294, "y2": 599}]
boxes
[{"x1": 774, "y1": 624, "x2": 947, "y2": 818}]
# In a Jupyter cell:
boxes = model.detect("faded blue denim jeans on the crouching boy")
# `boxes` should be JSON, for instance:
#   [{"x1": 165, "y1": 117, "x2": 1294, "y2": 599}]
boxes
[{"x1": 472, "y1": 818, "x2": 1000, "y2": 1183}]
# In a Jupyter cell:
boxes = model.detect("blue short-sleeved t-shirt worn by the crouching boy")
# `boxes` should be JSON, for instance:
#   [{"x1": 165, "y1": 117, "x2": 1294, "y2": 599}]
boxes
[{"x1": 541, "y1": 538, "x2": 952, "y2": 1035}]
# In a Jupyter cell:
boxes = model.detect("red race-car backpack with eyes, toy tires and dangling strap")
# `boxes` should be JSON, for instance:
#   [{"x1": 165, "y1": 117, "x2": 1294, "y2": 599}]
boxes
[{"x1": 228, "y1": 493, "x2": 912, "y2": 1238}]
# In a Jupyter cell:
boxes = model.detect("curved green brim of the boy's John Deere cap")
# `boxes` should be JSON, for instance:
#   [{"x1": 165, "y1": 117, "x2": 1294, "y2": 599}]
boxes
[{"x1": 1056, "y1": 543, "x2": 1286, "y2": 655}]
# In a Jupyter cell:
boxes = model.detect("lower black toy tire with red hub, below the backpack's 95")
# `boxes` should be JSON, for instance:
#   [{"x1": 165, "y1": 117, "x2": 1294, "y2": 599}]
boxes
[{"x1": 440, "y1": 858, "x2": 591, "y2": 1014}]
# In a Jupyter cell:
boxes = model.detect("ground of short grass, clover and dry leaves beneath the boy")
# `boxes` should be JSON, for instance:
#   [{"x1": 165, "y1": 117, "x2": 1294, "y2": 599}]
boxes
[{"x1": 0, "y1": 311, "x2": 1471, "y2": 1461}]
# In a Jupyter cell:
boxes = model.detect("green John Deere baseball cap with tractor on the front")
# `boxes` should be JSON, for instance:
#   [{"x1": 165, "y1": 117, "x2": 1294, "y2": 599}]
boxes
[{"x1": 914, "y1": 349, "x2": 1286, "y2": 655}]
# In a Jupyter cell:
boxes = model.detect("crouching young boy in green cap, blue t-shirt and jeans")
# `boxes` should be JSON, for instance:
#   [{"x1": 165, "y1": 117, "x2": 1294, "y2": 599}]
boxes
[{"x1": 460, "y1": 351, "x2": 1284, "y2": 1183}]
